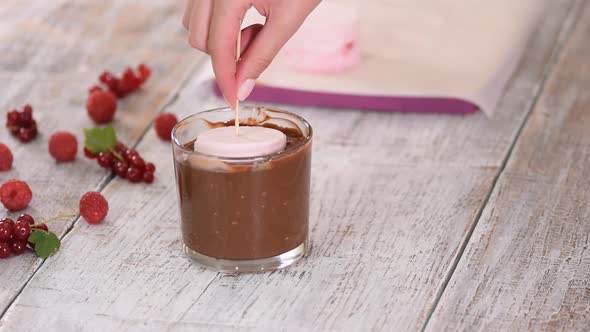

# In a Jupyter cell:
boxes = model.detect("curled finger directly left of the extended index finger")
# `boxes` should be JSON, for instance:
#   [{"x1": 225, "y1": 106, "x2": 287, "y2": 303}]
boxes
[{"x1": 188, "y1": 0, "x2": 213, "y2": 53}]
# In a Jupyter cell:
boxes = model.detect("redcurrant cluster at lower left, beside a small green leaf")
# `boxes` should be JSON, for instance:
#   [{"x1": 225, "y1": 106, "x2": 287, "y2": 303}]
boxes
[{"x1": 0, "y1": 214, "x2": 49, "y2": 258}]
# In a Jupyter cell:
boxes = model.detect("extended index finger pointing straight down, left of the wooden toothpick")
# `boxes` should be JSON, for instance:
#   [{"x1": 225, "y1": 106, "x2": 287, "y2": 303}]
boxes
[{"x1": 207, "y1": 0, "x2": 249, "y2": 107}]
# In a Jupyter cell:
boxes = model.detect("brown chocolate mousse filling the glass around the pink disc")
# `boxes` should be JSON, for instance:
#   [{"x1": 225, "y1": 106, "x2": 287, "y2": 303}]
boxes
[{"x1": 175, "y1": 109, "x2": 311, "y2": 260}]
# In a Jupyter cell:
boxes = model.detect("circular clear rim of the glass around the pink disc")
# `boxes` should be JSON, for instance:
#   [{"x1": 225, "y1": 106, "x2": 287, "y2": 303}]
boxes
[{"x1": 171, "y1": 105, "x2": 313, "y2": 163}]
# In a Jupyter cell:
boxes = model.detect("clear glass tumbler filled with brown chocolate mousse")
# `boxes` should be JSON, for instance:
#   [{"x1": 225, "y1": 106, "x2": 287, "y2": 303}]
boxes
[{"x1": 172, "y1": 107, "x2": 312, "y2": 272}]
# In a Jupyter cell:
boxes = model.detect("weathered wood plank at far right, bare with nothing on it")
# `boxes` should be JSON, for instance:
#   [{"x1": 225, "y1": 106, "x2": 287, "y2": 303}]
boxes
[{"x1": 427, "y1": 2, "x2": 590, "y2": 331}]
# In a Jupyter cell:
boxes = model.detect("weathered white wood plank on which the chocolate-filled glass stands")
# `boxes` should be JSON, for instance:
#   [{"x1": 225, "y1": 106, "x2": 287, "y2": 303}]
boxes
[{"x1": 0, "y1": 1, "x2": 572, "y2": 331}]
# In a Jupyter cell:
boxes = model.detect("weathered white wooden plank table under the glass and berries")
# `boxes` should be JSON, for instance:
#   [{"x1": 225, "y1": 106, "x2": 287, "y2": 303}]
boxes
[{"x1": 0, "y1": 0, "x2": 590, "y2": 332}]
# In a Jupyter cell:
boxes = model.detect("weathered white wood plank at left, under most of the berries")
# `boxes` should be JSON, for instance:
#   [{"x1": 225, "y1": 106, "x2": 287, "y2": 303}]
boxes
[{"x1": 0, "y1": 0, "x2": 202, "y2": 313}]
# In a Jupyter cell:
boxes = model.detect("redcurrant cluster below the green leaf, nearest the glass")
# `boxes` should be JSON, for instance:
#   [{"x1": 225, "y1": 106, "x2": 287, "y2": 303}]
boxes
[{"x1": 84, "y1": 142, "x2": 156, "y2": 183}]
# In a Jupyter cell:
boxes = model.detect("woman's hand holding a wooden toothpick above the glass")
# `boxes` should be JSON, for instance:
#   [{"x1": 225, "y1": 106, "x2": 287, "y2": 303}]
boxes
[{"x1": 183, "y1": 0, "x2": 321, "y2": 107}]
